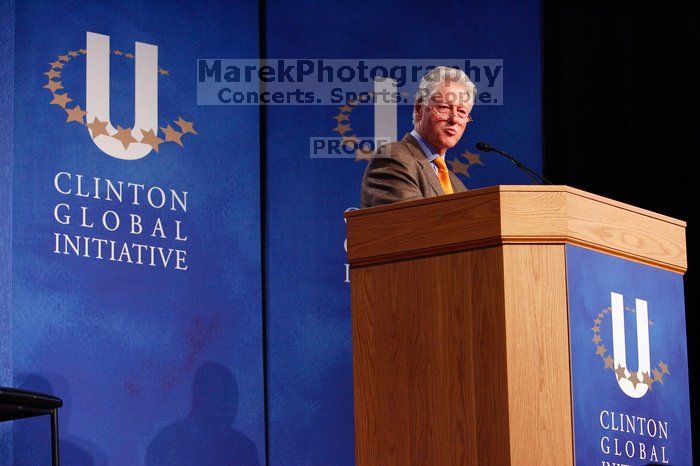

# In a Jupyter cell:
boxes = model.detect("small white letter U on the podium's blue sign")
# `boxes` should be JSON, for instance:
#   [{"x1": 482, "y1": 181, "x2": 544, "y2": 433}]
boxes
[{"x1": 610, "y1": 292, "x2": 651, "y2": 398}]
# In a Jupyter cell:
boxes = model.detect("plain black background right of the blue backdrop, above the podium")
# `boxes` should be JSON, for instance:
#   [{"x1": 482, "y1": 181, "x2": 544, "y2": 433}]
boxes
[{"x1": 542, "y1": 1, "x2": 700, "y2": 458}]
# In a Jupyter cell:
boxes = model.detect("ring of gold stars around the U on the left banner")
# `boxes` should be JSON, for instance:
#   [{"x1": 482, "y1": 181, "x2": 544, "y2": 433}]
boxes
[{"x1": 43, "y1": 49, "x2": 197, "y2": 152}]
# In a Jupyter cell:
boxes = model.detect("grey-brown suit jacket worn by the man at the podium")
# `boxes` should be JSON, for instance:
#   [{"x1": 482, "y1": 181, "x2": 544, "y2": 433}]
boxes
[{"x1": 362, "y1": 133, "x2": 467, "y2": 207}]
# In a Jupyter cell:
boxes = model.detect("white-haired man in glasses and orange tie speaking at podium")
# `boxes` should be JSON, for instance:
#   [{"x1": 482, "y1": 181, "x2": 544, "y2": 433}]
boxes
[{"x1": 362, "y1": 66, "x2": 476, "y2": 207}]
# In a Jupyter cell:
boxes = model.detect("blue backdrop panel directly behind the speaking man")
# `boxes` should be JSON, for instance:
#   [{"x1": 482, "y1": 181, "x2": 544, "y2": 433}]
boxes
[{"x1": 264, "y1": 0, "x2": 542, "y2": 466}]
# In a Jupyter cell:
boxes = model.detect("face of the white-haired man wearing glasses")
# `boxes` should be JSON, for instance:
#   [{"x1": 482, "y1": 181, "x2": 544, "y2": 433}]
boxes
[{"x1": 416, "y1": 81, "x2": 474, "y2": 155}]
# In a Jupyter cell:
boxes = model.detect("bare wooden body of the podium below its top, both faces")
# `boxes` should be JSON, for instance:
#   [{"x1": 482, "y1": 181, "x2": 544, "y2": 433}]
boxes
[{"x1": 351, "y1": 245, "x2": 573, "y2": 466}]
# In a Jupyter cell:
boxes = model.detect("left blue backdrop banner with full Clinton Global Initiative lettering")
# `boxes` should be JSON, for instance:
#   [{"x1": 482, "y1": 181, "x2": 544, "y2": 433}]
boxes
[{"x1": 3, "y1": 0, "x2": 265, "y2": 465}]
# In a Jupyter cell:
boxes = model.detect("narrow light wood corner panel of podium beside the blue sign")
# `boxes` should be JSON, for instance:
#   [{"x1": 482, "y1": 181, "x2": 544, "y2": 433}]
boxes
[{"x1": 504, "y1": 245, "x2": 573, "y2": 466}]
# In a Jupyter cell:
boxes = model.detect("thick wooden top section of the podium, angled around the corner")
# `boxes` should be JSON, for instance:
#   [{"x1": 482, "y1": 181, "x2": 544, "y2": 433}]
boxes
[{"x1": 345, "y1": 186, "x2": 687, "y2": 273}]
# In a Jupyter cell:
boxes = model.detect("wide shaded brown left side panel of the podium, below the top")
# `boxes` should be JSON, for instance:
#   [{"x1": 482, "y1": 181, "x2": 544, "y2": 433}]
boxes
[{"x1": 351, "y1": 248, "x2": 509, "y2": 465}]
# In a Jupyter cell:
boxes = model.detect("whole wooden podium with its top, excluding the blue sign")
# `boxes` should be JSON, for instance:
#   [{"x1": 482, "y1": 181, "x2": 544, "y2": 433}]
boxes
[{"x1": 346, "y1": 186, "x2": 687, "y2": 466}]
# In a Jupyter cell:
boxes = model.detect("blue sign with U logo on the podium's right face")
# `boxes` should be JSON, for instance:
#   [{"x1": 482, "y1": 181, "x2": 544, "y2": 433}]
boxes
[{"x1": 566, "y1": 246, "x2": 693, "y2": 465}]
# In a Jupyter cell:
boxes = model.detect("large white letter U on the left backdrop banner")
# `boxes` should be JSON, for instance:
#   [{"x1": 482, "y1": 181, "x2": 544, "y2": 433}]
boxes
[{"x1": 85, "y1": 32, "x2": 158, "y2": 160}]
